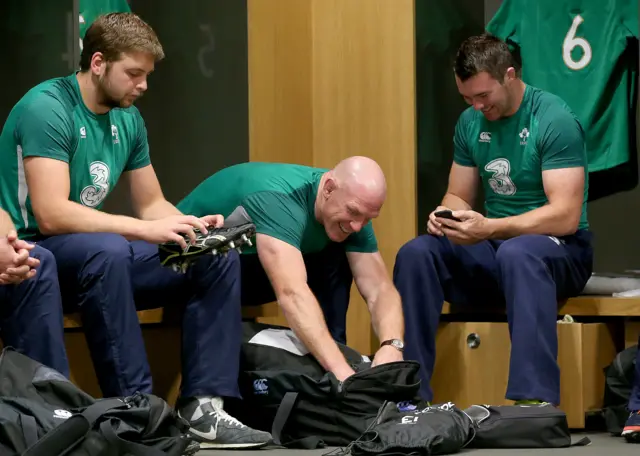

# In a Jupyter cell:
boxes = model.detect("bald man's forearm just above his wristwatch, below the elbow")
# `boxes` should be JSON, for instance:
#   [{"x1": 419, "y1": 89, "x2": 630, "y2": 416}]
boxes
[{"x1": 367, "y1": 283, "x2": 404, "y2": 342}]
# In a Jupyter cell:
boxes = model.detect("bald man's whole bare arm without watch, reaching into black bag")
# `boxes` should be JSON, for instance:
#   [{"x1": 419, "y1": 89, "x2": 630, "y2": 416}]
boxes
[{"x1": 256, "y1": 233, "x2": 353, "y2": 380}]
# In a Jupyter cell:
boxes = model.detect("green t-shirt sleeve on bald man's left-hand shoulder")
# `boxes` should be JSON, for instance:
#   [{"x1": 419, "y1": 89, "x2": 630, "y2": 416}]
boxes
[{"x1": 240, "y1": 191, "x2": 309, "y2": 249}]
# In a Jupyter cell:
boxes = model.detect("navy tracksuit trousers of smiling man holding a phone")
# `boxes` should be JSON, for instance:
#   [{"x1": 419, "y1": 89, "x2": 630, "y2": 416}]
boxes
[{"x1": 393, "y1": 231, "x2": 592, "y2": 404}]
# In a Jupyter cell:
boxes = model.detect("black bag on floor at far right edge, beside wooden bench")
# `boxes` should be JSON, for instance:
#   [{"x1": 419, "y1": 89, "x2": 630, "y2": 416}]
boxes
[{"x1": 602, "y1": 345, "x2": 638, "y2": 435}]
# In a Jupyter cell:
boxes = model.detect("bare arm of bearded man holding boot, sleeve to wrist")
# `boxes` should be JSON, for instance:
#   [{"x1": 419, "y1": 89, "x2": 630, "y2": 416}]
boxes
[{"x1": 24, "y1": 157, "x2": 144, "y2": 239}]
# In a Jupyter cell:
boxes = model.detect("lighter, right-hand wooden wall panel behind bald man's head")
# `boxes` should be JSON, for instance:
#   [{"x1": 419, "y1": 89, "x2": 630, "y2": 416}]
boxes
[{"x1": 311, "y1": 0, "x2": 416, "y2": 351}]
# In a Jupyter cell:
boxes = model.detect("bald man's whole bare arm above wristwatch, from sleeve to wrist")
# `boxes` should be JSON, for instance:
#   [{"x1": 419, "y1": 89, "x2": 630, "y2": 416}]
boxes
[{"x1": 347, "y1": 252, "x2": 404, "y2": 341}]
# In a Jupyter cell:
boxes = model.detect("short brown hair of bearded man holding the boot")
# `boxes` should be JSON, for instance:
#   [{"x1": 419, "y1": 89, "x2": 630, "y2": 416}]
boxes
[{"x1": 80, "y1": 13, "x2": 164, "y2": 71}]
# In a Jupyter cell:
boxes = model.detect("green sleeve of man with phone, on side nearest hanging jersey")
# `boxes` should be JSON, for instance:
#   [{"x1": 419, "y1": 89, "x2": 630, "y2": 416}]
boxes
[{"x1": 538, "y1": 111, "x2": 587, "y2": 171}]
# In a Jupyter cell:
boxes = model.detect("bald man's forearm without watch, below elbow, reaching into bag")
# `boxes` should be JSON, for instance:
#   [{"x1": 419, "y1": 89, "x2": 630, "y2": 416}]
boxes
[{"x1": 278, "y1": 284, "x2": 349, "y2": 373}]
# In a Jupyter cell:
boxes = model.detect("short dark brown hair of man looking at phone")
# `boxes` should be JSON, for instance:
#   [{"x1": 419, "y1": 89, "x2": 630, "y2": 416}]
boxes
[{"x1": 454, "y1": 33, "x2": 520, "y2": 83}]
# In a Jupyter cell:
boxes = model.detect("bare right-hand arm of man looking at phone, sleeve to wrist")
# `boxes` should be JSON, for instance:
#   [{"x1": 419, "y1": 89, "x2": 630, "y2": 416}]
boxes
[{"x1": 487, "y1": 167, "x2": 585, "y2": 239}]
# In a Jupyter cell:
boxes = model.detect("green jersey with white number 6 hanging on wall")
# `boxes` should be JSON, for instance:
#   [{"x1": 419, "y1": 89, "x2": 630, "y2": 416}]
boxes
[{"x1": 487, "y1": 0, "x2": 638, "y2": 172}]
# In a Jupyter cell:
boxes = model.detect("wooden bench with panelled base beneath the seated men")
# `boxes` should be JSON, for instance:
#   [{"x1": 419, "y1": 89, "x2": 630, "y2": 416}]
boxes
[{"x1": 64, "y1": 296, "x2": 640, "y2": 429}]
